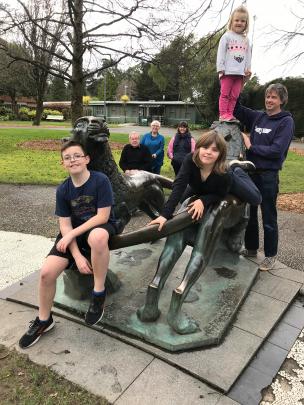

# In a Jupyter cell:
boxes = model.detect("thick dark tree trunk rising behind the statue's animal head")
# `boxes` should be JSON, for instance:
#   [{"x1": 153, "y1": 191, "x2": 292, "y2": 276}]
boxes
[{"x1": 71, "y1": 0, "x2": 84, "y2": 124}]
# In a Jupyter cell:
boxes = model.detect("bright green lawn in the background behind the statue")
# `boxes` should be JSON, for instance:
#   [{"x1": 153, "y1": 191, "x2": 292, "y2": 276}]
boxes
[{"x1": 0, "y1": 127, "x2": 304, "y2": 193}]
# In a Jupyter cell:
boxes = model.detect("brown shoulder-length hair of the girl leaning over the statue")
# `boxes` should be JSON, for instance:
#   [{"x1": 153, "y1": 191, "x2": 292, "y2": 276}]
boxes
[{"x1": 192, "y1": 130, "x2": 227, "y2": 174}]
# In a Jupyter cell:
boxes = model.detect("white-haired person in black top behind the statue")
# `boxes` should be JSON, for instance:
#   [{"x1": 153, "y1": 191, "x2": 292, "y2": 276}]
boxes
[{"x1": 119, "y1": 132, "x2": 152, "y2": 174}]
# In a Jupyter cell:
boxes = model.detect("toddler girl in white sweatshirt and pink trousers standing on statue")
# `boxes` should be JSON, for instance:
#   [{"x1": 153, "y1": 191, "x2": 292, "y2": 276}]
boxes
[{"x1": 216, "y1": 6, "x2": 251, "y2": 121}]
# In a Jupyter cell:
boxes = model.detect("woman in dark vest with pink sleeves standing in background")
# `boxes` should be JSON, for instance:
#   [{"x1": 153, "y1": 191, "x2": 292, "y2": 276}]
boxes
[{"x1": 167, "y1": 121, "x2": 195, "y2": 176}]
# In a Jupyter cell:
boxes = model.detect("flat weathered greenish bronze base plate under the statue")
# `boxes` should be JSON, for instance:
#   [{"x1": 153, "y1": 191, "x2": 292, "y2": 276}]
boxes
[{"x1": 55, "y1": 240, "x2": 258, "y2": 352}]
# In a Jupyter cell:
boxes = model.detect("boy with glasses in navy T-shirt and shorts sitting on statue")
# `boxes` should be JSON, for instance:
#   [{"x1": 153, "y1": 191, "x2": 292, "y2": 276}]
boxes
[{"x1": 19, "y1": 141, "x2": 117, "y2": 348}]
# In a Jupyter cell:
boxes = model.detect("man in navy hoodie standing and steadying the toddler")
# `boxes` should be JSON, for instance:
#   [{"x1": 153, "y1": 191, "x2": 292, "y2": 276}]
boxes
[{"x1": 234, "y1": 83, "x2": 294, "y2": 271}]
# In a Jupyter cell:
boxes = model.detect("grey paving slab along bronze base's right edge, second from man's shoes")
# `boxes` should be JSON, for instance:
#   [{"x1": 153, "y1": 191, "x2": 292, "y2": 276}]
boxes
[{"x1": 234, "y1": 291, "x2": 288, "y2": 338}]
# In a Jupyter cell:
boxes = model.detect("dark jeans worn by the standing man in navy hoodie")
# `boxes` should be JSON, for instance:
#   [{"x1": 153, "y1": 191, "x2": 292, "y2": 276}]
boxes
[{"x1": 245, "y1": 170, "x2": 279, "y2": 257}]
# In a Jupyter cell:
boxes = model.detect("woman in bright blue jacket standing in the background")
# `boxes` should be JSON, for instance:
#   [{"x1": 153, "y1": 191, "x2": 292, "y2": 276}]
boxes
[{"x1": 140, "y1": 121, "x2": 165, "y2": 174}]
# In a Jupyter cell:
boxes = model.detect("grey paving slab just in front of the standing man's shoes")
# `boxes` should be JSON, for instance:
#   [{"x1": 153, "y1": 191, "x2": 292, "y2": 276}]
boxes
[{"x1": 251, "y1": 270, "x2": 301, "y2": 302}]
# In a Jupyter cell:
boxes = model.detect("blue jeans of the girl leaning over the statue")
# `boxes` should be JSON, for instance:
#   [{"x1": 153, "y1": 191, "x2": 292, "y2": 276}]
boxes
[{"x1": 229, "y1": 167, "x2": 262, "y2": 205}]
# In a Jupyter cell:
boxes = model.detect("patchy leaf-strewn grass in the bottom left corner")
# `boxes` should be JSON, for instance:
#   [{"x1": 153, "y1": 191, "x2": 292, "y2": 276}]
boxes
[{"x1": 0, "y1": 345, "x2": 109, "y2": 405}]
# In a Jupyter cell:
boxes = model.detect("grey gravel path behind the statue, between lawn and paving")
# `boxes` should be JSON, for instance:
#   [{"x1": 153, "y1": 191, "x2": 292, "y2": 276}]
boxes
[{"x1": 0, "y1": 184, "x2": 304, "y2": 271}]
